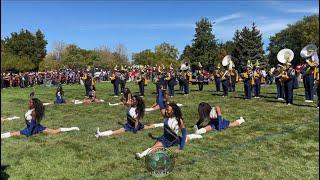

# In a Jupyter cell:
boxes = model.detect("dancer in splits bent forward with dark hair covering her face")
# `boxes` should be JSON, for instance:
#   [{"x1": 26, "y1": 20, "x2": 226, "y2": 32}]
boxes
[{"x1": 194, "y1": 102, "x2": 245, "y2": 134}]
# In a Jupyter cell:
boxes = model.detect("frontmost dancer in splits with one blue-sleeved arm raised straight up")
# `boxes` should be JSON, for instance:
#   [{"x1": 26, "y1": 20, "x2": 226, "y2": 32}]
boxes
[{"x1": 136, "y1": 91, "x2": 202, "y2": 159}]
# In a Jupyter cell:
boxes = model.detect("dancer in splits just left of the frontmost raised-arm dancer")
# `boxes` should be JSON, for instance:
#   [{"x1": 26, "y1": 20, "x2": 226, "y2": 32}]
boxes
[{"x1": 95, "y1": 96, "x2": 163, "y2": 138}]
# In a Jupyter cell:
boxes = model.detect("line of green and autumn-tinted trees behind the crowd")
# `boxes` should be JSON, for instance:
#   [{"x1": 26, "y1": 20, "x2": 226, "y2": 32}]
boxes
[{"x1": 1, "y1": 15, "x2": 319, "y2": 72}]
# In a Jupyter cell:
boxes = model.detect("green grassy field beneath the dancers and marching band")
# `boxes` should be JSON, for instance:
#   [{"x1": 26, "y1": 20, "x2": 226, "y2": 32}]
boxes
[{"x1": 1, "y1": 83, "x2": 319, "y2": 179}]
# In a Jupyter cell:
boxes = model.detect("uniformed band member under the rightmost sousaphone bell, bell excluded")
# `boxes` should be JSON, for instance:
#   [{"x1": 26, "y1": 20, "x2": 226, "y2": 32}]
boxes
[{"x1": 302, "y1": 57, "x2": 316, "y2": 102}]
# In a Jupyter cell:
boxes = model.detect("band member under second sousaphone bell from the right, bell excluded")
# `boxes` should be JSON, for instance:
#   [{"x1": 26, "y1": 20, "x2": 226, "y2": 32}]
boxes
[{"x1": 281, "y1": 63, "x2": 295, "y2": 105}]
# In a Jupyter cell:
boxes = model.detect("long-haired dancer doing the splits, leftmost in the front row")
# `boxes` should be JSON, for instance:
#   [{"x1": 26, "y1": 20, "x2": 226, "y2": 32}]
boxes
[{"x1": 1, "y1": 98, "x2": 79, "y2": 139}]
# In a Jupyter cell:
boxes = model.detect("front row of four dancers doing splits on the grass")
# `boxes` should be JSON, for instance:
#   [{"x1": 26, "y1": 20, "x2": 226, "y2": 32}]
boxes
[{"x1": 1, "y1": 87, "x2": 245, "y2": 162}]
